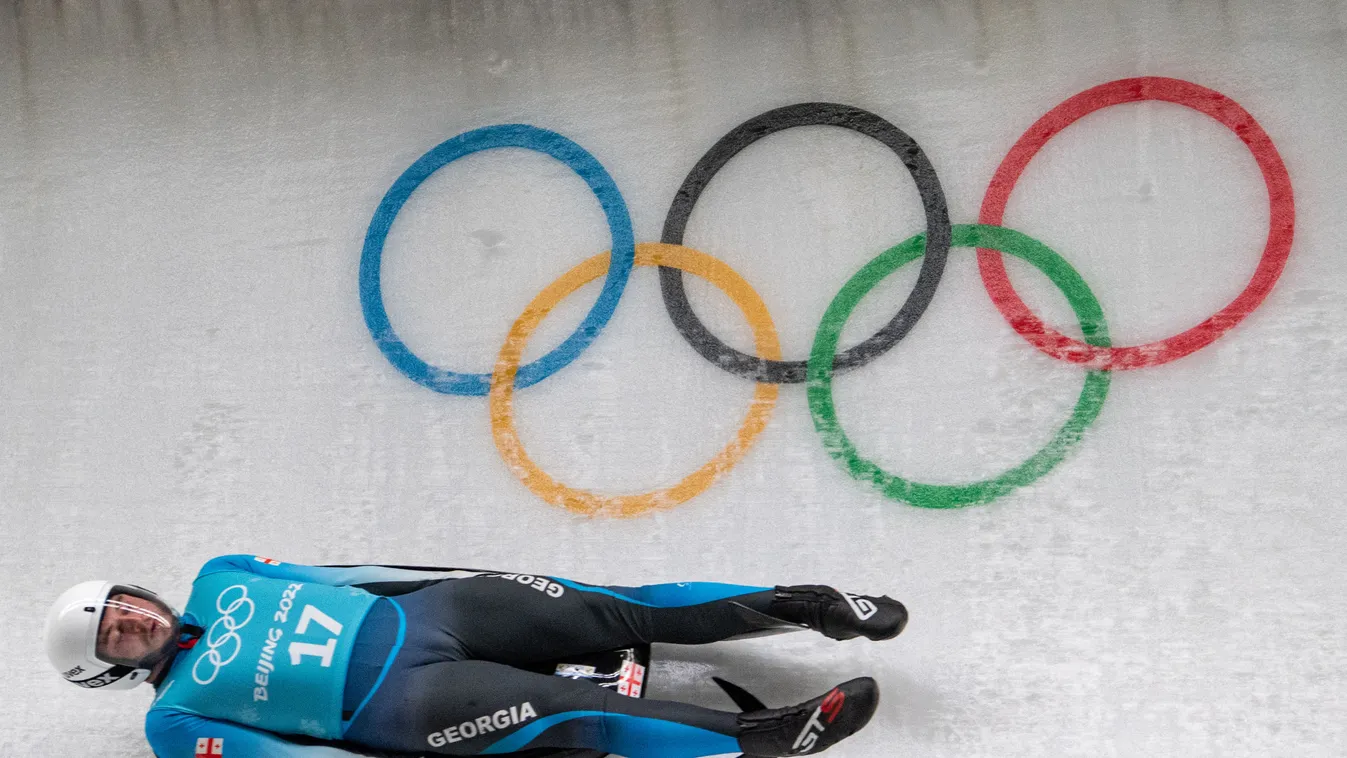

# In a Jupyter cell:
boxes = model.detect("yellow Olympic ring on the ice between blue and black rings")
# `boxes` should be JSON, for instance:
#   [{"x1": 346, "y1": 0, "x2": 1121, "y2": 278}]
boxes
[{"x1": 488, "y1": 242, "x2": 781, "y2": 516}]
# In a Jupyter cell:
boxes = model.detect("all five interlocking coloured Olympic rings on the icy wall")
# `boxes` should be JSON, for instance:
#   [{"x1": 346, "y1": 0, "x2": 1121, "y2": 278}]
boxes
[{"x1": 360, "y1": 77, "x2": 1296, "y2": 516}]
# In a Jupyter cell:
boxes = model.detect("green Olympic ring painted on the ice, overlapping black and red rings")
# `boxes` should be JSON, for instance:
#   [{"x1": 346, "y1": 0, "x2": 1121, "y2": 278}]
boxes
[{"x1": 807, "y1": 223, "x2": 1110, "y2": 508}]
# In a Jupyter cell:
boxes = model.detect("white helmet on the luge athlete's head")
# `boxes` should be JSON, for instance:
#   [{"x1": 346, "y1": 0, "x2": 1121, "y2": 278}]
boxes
[{"x1": 43, "y1": 580, "x2": 182, "y2": 689}]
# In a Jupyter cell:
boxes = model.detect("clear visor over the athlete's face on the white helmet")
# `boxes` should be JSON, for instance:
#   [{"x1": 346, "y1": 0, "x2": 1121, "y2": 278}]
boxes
[{"x1": 94, "y1": 584, "x2": 179, "y2": 668}]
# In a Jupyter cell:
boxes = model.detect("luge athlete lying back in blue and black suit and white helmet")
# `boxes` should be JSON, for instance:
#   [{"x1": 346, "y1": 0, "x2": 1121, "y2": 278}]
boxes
[{"x1": 46, "y1": 555, "x2": 907, "y2": 758}]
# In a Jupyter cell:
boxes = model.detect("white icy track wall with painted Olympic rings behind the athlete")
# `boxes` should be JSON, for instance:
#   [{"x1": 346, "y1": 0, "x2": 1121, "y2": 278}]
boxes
[{"x1": 0, "y1": 0, "x2": 1347, "y2": 758}]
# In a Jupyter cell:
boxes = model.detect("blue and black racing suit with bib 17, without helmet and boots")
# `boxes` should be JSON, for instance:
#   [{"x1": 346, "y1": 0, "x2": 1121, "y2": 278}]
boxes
[{"x1": 145, "y1": 556, "x2": 772, "y2": 758}]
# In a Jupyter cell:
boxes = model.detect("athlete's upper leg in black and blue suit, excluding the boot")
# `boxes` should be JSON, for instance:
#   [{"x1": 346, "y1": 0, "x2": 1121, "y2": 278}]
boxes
[{"x1": 397, "y1": 574, "x2": 775, "y2": 664}]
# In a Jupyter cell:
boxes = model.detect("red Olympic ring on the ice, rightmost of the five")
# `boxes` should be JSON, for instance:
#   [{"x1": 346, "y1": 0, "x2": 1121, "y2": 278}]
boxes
[{"x1": 978, "y1": 77, "x2": 1296, "y2": 370}]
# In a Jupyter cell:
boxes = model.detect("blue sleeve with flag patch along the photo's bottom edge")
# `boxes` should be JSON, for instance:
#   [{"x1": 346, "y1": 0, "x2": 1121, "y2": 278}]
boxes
[{"x1": 145, "y1": 708, "x2": 398, "y2": 758}]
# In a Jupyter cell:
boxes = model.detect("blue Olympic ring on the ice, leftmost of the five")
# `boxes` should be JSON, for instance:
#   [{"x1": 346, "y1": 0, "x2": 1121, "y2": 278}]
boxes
[{"x1": 360, "y1": 124, "x2": 636, "y2": 394}]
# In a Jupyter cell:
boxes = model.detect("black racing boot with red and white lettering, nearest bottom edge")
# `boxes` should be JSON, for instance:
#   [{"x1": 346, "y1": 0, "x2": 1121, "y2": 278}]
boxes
[{"x1": 740, "y1": 676, "x2": 880, "y2": 758}]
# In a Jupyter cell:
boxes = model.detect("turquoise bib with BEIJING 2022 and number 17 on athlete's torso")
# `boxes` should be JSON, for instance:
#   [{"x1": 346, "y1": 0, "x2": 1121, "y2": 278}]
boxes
[{"x1": 154, "y1": 559, "x2": 377, "y2": 739}]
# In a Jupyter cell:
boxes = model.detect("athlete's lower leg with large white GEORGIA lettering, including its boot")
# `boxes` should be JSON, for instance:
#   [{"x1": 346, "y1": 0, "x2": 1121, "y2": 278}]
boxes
[{"x1": 345, "y1": 661, "x2": 878, "y2": 758}]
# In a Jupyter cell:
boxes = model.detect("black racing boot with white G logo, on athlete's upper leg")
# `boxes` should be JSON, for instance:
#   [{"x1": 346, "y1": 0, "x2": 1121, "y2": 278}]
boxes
[{"x1": 768, "y1": 584, "x2": 908, "y2": 640}]
